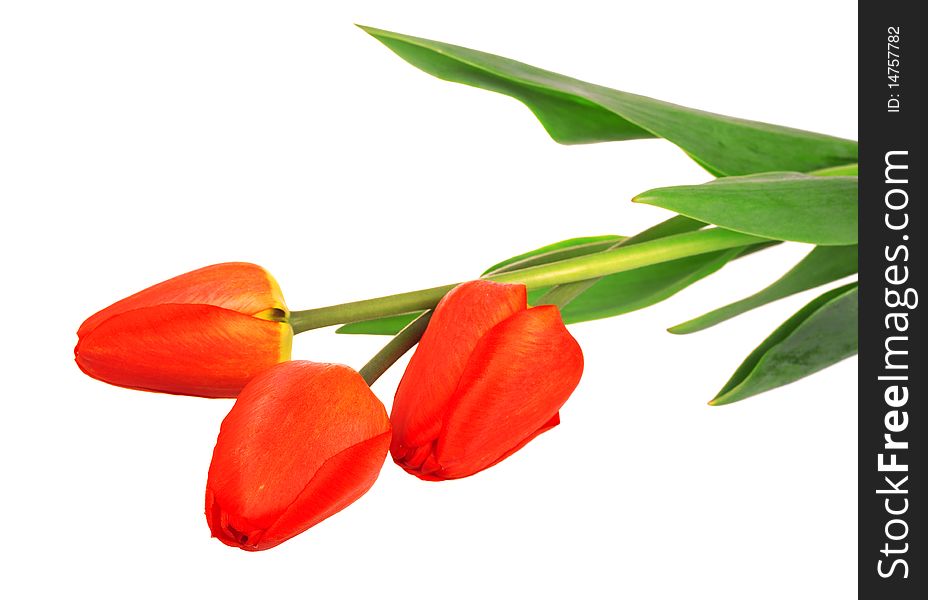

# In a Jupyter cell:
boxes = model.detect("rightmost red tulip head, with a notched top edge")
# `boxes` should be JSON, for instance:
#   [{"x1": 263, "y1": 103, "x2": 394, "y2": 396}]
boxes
[{"x1": 390, "y1": 281, "x2": 583, "y2": 481}]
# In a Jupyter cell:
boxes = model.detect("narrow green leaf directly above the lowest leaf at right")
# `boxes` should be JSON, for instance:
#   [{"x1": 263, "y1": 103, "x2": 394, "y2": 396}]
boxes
[{"x1": 668, "y1": 246, "x2": 857, "y2": 334}]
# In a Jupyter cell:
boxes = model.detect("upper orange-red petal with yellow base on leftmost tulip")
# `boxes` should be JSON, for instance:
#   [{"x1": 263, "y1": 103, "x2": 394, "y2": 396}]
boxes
[{"x1": 77, "y1": 263, "x2": 289, "y2": 337}]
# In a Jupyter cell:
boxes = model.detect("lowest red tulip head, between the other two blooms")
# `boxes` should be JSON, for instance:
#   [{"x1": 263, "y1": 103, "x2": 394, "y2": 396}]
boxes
[{"x1": 206, "y1": 361, "x2": 390, "y2": 550}]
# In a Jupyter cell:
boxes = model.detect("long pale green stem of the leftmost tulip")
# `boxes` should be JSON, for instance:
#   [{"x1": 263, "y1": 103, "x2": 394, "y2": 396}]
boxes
[{"x1": 289, "y1": 228, "x2": 770, "y2": 333}]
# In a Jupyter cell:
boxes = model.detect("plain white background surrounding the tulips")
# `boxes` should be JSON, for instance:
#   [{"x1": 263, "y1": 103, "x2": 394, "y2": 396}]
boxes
[{"x1": 0, "y1": 1, "x2": 857, "y2": 600}]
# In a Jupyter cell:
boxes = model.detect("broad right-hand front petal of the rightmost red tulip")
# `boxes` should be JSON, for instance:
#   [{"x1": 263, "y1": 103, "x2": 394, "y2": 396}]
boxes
[{"x1": 435, "y1": 306, "x2": 583, "y2": 479}]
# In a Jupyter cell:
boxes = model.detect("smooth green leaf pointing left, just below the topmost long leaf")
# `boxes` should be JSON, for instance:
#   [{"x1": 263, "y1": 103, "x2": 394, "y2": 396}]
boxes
[{"x1": 634, "y1": 173, "x2": 857, "y2": 246}]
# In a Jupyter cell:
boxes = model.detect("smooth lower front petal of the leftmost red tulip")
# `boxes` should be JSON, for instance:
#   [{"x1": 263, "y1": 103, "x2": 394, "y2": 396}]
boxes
[{"x1": 74, "y1": 304, "x2": 293, "y2": 398}]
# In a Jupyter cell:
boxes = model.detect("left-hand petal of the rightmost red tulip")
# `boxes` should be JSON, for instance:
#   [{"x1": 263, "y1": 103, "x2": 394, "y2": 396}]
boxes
[{"x1": 390, "y1": 280, "x2": 526, "y2": 460}]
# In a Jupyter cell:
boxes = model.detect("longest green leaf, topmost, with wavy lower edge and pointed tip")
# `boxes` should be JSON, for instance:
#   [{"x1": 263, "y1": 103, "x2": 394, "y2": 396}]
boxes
[{"x1": 361, "y1": 27, "x2": 857, "y2": 176}]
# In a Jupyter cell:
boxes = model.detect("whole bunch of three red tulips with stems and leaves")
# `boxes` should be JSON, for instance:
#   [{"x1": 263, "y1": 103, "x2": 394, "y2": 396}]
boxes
[{"x1": 75, "y1": 29, "x2": 857, "y2": 550}]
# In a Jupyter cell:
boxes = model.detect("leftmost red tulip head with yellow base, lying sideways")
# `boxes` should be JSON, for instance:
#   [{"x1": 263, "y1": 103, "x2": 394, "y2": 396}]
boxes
[{"x1": 74, "y1": 263, "x2": 293, "y2": 398}]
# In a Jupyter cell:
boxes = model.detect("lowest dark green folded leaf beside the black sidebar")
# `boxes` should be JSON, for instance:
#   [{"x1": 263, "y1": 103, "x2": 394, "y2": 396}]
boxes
[{"x1": 709, "y1": 282, "x2": 857, "y2": 406}]
